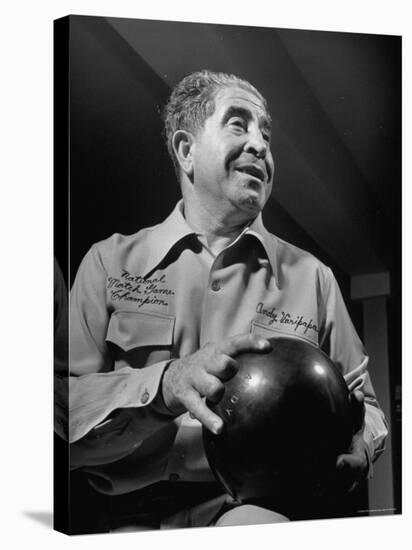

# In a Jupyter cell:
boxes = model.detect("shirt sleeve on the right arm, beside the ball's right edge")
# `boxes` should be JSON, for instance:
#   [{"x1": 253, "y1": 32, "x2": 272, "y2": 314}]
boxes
[{"x1": 320, "y1": 268, "x2": 388, "y2": 476}]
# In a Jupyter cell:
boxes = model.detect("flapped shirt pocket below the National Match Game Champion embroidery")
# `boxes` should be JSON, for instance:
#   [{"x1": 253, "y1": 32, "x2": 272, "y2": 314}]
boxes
[{"x1": 106, "y1": 310, "x2": 175, "y2": 369}]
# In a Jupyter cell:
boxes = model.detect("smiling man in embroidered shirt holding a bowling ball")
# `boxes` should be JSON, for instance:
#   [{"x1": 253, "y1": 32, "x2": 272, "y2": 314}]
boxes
[{"x1": 69, "y1": 71, "x2": 386, "y2": 529}]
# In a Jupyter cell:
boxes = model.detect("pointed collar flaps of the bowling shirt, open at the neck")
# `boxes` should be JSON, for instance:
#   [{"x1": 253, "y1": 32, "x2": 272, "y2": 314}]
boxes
[{"x1": 143, "y1": 203, "x2": 279, "y2": 283}]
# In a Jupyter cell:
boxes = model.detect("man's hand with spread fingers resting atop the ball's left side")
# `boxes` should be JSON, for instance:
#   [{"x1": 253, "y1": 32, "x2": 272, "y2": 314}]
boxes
[{"x1": 162, "y1": 334, "x2": 271, "y2": 434}]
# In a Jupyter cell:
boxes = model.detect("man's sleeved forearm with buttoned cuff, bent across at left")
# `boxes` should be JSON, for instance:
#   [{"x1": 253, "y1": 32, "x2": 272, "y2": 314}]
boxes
[{"x1": 69, "y1": 361, "x2": 174, "y2": 468}]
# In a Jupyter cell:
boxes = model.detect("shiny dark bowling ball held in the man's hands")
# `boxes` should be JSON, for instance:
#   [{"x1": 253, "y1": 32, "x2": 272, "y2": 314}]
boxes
[{"x1": 203, "y1": 337, "x2": 353, "y2": 509}]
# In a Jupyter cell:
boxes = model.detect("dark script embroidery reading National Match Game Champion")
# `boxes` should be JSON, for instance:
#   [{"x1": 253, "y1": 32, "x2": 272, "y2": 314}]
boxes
[{"x1": 107, "y1": 269, "x2": 175, "y2": 308}]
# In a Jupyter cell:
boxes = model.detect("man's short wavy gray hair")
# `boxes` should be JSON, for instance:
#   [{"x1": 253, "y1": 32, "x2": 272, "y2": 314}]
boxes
[{"x1": 163, "y1": 70, "x2": 267, "y2": 175}]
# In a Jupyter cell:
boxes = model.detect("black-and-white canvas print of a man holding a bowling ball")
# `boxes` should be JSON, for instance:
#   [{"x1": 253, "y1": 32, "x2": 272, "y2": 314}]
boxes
[{"x1": 54, "y1": 15, "x2": 401, "y2": 535}]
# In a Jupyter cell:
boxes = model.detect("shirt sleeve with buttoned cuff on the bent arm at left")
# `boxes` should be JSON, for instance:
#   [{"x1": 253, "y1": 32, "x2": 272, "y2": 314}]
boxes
[{"x1": 68, "y1": 245, "x2": 173, "y2": 467}]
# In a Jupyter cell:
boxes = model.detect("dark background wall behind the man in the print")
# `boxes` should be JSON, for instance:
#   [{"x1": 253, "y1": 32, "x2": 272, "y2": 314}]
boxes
[{"x1": 55, "y1": 16, "x2": 401, "y2": 528}]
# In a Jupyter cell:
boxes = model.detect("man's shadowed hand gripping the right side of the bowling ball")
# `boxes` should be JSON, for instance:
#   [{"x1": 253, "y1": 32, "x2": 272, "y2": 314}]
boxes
[{"x1": 336, "y1": 390, "x2": 369, "y2": 493}]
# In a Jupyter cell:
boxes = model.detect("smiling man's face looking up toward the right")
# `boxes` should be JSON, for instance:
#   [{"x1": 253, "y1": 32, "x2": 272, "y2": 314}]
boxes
[{"x1": 193, "y1": 87, "x2": 274, "y2": 221}]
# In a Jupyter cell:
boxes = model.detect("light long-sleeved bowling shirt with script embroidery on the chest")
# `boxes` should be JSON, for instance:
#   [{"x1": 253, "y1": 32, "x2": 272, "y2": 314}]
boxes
[{"x1": 69, "y1": 201, "x2": 387, "y2": 494}]
